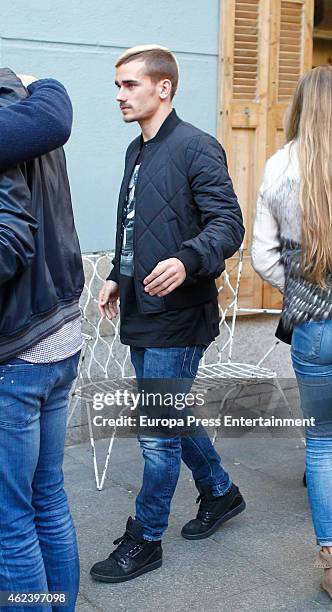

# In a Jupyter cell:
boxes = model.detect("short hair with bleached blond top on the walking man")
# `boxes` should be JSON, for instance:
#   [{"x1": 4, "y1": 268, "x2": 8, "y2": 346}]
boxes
[{"x1": 115, "y1": 45, "x2": 179, "y2": 98}]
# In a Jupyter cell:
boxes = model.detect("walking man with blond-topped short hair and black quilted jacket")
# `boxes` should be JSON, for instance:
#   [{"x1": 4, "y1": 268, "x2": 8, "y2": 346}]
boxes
[{"x1": 91, "y1": 46, "x2": 245, "y2": 582}]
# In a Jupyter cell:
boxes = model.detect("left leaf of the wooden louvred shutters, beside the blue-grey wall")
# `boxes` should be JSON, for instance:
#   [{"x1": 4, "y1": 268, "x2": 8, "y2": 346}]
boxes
[{"x1": 218, "y1": 0, "x2": 269, "y2": 307}]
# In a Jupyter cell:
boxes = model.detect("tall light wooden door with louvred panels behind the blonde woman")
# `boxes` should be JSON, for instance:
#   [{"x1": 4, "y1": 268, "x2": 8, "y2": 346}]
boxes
[{"x1": 218, "y1": 0, "x2": 313, "y2": 308}]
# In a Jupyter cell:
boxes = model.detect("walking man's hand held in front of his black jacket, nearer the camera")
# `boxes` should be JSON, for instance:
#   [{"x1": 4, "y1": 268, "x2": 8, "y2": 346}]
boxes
[{"x1": 143, "y1": 257, "x2": 187, "y2": 297}]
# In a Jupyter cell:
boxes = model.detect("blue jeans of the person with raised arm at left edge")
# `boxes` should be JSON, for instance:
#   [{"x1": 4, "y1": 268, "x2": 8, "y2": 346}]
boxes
[{"x1": 0, "y1": 353, "x2": 79, "y2": 612}]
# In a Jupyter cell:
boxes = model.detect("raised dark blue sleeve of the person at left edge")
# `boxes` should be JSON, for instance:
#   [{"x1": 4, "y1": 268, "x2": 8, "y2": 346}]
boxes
[{"x1": 0, "y1": 79, "x2": 73, "y2": 172}]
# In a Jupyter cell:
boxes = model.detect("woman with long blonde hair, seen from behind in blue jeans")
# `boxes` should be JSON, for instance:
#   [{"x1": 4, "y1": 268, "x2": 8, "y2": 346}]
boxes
[{"x1": 252, "y1": 66, "x2": 332, "y2": 597}]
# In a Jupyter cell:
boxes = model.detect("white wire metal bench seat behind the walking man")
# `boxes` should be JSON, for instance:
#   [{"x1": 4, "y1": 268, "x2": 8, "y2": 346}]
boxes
[{"x1": 68, "y1": 247, "x2": 302, "y2": 490}]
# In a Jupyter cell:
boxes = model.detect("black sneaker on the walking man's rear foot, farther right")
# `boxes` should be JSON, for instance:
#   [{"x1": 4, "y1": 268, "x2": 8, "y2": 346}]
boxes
[{"x1": 181, "y1": 484, "x2": 246, "y2": 540}]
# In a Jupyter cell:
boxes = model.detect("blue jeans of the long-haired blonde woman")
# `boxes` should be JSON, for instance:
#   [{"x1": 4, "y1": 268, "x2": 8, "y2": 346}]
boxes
[{"x1": 292, "y1": 320, "x2": 332, "y2": 546}]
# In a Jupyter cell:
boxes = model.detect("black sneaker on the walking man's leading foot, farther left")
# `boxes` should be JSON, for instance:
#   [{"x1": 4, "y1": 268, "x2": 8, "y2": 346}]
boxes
[{"x1": 90, "y1": 516, "x2": 163, "y2": 582}]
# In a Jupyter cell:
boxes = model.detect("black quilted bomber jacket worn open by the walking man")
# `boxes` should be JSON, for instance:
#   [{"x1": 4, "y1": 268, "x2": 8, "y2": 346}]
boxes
[{"x1": 108, "y1": 110, "x2": 244, "y2": 314}]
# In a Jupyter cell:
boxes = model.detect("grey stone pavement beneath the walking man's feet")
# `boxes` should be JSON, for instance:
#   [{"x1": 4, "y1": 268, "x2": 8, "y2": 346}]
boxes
[{"x1": 65, "y1": 320, "x2": 332, "y2": 612}]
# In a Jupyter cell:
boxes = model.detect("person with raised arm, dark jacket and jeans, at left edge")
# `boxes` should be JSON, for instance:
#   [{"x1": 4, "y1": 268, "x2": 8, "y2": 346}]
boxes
[{"x1": 0, "y1": 68, "x2": 84, "y2": 612}]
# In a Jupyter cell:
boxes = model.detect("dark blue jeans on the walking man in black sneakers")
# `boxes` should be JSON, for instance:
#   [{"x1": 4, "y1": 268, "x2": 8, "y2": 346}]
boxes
[{"x1": 130, "y1": 346, "x2": 232, "y2": 540}]
